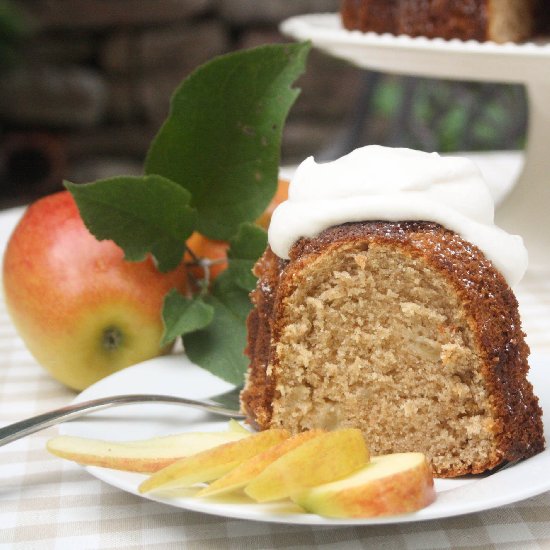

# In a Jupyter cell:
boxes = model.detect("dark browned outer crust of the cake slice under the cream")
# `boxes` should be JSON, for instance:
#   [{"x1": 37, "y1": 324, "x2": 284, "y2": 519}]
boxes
[{"x1": 242, "y1": 222, "x2": 544, "y2": 477}]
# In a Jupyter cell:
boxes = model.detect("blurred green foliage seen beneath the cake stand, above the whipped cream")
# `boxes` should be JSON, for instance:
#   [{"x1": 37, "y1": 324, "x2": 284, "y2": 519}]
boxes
[{"x1": 363, "y1": 75, "x2": 527, "y2": 152}]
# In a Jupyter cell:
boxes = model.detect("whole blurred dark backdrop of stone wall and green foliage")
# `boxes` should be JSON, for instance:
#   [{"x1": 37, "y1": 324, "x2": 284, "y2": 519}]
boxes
[{"x1": 0, "y1": 0, "x2": 527, "y2": 208}]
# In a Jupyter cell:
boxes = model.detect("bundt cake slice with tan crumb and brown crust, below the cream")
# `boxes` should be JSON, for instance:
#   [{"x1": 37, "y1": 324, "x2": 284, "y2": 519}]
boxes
[{"x1": 241, "y1": 221, "x2": 544, "y2": 477}]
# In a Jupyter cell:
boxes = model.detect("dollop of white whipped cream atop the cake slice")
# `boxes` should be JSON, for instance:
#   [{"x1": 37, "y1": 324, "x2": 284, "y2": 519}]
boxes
[{"x1": 268, "y1": 145, "x2": 527, "y2": 286}]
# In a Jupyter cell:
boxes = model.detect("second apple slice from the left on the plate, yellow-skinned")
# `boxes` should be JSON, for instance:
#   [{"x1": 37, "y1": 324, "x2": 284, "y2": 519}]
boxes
[{"x1": 139, "y1": 429, "x2": 290, "y2": 493}]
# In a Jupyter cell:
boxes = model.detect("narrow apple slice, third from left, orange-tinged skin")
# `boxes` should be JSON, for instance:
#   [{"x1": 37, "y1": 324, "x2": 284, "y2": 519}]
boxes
[{"x1": 199, "y1": 430, "x2": 325, "y2": 497}]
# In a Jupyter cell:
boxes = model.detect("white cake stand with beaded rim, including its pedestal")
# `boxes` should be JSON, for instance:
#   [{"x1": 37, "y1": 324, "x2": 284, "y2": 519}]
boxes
[{"x1": 281, "y1": 14, "x2": 550, "y2": 269}]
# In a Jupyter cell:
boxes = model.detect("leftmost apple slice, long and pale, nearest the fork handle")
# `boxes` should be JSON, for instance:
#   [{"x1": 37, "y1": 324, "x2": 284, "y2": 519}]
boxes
[{"x1": 46, "y1": 431, "x2": 251, "y2": 473}]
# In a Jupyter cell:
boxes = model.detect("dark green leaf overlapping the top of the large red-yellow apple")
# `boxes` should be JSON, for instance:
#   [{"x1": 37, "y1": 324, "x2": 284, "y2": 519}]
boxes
[{"x1": 65, "y1": 176, "x2": 197, "y2": 271}]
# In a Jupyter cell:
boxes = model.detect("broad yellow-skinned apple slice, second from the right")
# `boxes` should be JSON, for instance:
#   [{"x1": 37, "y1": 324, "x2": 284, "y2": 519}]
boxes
[{"x1": 244, "y1": 428, "x2": 369, "y2": 502}]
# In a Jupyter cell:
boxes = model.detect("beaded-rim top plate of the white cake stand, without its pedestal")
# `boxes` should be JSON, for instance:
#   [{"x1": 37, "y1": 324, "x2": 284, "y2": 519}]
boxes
[{"x1": 281, "y1": 13, "x2": 550, "y2": 82}]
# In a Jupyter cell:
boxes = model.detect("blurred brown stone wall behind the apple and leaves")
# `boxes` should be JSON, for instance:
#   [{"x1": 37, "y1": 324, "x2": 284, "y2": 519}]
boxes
[{"x1": 0, "y1": 0, "x2": 361, "y2": 206}]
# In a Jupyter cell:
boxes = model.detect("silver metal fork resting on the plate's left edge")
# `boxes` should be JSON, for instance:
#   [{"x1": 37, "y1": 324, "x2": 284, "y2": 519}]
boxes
[{"x1": 0, "y1": 387, "x2": 244, "y2": 447}]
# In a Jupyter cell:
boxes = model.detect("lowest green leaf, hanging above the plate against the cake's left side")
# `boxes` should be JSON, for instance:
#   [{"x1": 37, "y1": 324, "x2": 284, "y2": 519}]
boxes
[{"x1": 183, "y1": 296, "x2": 248, "y2": 385}]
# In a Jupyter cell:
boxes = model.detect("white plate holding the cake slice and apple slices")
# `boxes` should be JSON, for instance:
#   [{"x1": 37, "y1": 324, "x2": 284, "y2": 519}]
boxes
[{"x1": 60, "y1": 355, "x2": 550, "y2": 525}]
